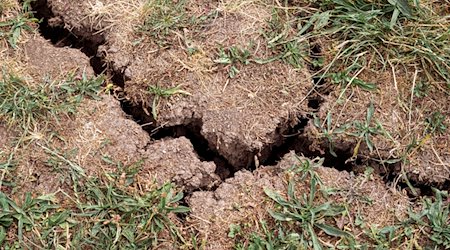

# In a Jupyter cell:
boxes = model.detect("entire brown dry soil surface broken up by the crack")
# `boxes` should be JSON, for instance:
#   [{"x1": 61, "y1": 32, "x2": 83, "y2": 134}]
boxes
[{"x1": 0, "y1": 0, "x2": 450, "y2": 249}]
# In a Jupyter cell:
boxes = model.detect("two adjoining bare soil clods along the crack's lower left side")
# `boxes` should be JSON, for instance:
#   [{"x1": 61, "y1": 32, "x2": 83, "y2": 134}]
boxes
[{"x1": 55, "y1": 96, "x2": 219, "y2": 190}]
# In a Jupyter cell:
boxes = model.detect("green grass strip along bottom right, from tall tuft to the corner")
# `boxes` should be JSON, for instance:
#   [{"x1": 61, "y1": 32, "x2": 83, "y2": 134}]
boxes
[{"x1": 232, "y1": 155, "x2": 450, "y2": 250}]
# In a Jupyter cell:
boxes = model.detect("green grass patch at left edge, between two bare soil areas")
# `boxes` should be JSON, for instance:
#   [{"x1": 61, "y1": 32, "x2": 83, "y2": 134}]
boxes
[{"x1": 0, "y1": 68, "x2": 104, "y2": 131}]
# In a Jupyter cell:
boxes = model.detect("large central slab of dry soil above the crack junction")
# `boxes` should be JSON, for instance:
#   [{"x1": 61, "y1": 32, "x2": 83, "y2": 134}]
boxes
[{"x1": 38, "y1": 0, "x2": 312, "y2": 169}]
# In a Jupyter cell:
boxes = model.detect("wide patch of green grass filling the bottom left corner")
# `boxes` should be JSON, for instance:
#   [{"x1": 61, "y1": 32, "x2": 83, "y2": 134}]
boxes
[{"x1": 0, "y1": 143, "x2": 189, "y2": 249}]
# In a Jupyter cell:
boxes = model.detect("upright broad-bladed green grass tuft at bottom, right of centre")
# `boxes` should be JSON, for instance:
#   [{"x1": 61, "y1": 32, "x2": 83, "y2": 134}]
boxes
[{"x1": 230, "y1": 159, "x2": 351, "y2": 249}]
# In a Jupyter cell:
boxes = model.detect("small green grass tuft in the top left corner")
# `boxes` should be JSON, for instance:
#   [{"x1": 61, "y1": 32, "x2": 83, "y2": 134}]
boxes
[{"x1": 0, "y1": 0, "x2": 39, "y2": 48}]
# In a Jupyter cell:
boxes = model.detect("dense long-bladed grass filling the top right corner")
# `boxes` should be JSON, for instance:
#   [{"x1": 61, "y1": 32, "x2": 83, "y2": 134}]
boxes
[{"x1": 299, "y1": 0, "x2": 450, "y2": 86}]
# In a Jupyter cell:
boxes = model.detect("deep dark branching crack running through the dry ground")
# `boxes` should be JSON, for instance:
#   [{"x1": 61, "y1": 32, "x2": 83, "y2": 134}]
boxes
[{"x1": 32, "y1": 0, "x2": 450, "y2": 198}]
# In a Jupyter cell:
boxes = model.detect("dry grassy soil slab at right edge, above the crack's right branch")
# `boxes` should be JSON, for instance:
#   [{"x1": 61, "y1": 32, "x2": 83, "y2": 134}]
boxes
[{"x1": 307, "y1": 67, "x2": 450, "y2": 184}]
